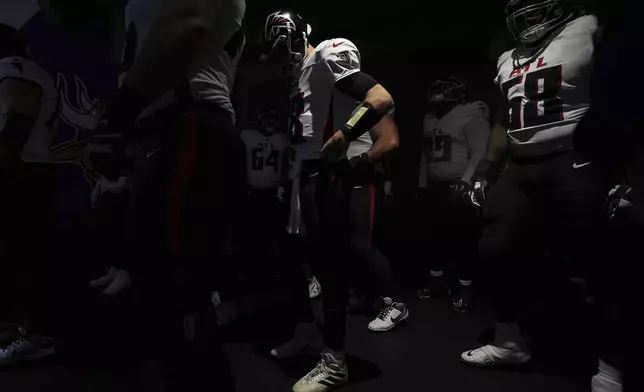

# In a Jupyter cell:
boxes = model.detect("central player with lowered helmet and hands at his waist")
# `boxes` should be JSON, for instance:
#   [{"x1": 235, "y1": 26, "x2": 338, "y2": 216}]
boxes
[{"x1": 265, "y1": 11, "x2": 398, "y2": 392}]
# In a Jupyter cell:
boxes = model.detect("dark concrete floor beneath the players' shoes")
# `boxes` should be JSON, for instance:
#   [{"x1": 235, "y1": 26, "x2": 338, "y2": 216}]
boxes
[{"x1": 0, "y1": 290, "x2": 589, "y2": 392}]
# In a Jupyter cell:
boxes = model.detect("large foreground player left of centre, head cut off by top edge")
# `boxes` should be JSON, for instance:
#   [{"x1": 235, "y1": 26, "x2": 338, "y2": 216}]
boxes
[{"x1": 85, "y1": 0, "x2": 247, "y2": 391}]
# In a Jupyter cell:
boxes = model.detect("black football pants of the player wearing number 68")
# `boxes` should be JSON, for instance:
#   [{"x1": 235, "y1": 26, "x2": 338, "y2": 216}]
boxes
[{"x1": 479, "y1": 152, "x2": 610, "y2": 323}]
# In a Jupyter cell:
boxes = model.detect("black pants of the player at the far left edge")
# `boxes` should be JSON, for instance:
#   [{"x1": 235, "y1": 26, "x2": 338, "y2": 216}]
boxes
[{"x1": 0, "y1": 163, "x2": 54, "y2": 334}]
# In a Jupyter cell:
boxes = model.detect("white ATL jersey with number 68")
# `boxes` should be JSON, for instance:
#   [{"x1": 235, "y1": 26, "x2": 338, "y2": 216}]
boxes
[{"x1": 495, "y1": 15, "x2": 597, "y2": 156}]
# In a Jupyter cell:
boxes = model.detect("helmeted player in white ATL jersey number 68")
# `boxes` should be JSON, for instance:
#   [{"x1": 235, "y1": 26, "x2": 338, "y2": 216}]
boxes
[{"x1": 461, "y1": 0, "x2": 610, "y2": 367}]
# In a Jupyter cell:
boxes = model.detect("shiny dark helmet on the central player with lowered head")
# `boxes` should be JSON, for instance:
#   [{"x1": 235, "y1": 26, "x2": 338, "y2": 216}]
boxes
[{"x1": 264, "y1": 10, "x2": 311, "y2": 63}]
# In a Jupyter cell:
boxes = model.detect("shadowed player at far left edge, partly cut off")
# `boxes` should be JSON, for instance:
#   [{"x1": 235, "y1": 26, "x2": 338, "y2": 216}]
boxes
[{"x1": 0, "y1": 24, "x2": 60, "y2": 366}]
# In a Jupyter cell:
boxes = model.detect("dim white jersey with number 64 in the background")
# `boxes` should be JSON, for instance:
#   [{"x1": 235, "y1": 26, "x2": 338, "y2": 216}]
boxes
[{"x1": 241, "y1": 129, "x2": 288, "y2": 190}]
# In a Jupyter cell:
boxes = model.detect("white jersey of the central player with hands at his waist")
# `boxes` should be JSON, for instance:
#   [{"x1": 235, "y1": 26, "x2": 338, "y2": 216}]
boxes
[{"x1": 293, "y1": 38, "x2": 373, "y2": 160}]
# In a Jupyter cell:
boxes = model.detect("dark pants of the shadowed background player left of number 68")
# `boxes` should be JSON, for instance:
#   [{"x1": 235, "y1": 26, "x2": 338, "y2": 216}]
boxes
[{"x1": 416, "y1": 180, "x2": 481, "y2": 280}]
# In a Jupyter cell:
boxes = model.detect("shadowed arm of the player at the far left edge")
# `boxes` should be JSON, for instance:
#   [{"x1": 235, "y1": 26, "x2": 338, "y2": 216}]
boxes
[{"x1": 0, "y1": 78, "x2": 42, "y2": 165}]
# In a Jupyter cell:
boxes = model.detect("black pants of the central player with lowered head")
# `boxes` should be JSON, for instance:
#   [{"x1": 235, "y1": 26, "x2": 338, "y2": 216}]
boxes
[{"x1": 301, "y1": 161, "x2": 400, "y2": 351}]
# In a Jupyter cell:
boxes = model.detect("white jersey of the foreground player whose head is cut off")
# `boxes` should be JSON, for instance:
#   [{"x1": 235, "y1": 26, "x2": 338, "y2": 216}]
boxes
[{"x1": 122, "y1": 0, "x2": 246, "y2": 121}]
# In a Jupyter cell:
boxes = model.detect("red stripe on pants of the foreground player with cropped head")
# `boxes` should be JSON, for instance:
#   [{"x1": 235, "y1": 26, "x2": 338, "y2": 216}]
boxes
[{"x1": 167, "y1": 112, "x2": 197, "y2": 252}]
